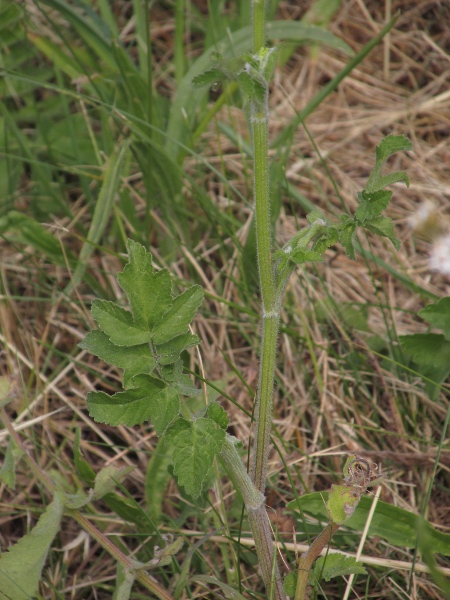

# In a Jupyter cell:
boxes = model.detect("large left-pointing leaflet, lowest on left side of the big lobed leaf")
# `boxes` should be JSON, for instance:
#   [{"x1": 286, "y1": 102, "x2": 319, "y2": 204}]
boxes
[{"x1": 87, "y1": 375, "x2": 180, "y2": 435}]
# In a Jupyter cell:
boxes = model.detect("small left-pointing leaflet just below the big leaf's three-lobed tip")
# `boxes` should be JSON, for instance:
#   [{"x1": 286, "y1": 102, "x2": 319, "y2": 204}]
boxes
[{"x1": 78, "y1": 330, "x2": 156, "y2": 377}]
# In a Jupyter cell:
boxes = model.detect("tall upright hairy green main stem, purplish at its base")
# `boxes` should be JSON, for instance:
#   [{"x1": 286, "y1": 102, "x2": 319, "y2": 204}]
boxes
[{"x1": 247, "y1": 0, "x2": 286, "y2": 600}]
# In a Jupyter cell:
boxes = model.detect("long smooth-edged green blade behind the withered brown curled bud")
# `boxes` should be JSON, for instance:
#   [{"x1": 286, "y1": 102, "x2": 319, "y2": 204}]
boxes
[{"x1": 288, "y1": 492, "x2": 450, "y2": 556}]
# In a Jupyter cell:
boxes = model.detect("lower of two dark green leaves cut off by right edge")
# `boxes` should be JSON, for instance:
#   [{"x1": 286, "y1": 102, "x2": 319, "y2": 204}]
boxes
[{"x1": 399, "y1": 333, "x2": 450, "y2": 367}]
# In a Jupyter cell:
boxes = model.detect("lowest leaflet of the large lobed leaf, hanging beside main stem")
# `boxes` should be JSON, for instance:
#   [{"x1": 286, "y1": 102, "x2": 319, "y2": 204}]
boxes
[{"x1": 165, "y1": 418, "x2": 225, "y2": 498}]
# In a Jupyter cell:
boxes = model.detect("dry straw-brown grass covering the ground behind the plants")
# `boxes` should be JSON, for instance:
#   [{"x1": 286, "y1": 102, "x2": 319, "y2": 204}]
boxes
[{"x1": 0, "y1": 0, "x2": 450, "y2": 600}]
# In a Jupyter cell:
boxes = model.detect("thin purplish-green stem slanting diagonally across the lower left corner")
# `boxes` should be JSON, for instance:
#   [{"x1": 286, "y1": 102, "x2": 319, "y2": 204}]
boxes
[{"x1": 0, "y1": 408, "x2": 173, "y2": 600}]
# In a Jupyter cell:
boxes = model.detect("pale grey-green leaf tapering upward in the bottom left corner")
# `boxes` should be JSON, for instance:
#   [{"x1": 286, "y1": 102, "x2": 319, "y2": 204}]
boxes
[{"x1": 0, "y1": 495, "x2": 64, "y2": 600}]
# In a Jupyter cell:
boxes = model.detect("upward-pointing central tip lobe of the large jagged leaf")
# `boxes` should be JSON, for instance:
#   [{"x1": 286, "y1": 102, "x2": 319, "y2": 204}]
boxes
[{"x1": 117, "y1": 239, "x2": 172, "y2": 330}]
